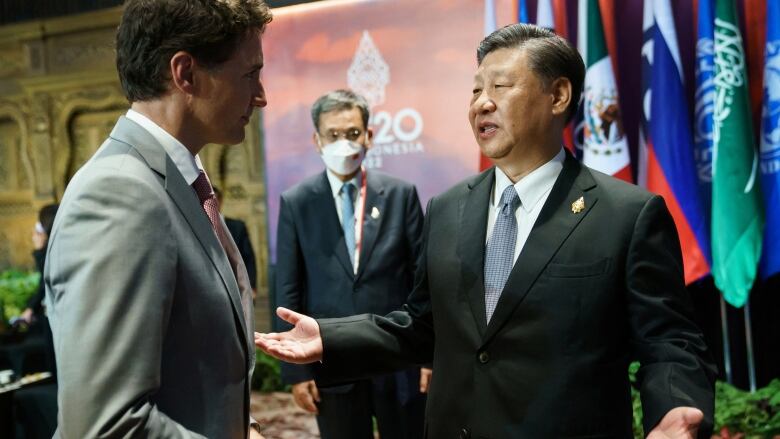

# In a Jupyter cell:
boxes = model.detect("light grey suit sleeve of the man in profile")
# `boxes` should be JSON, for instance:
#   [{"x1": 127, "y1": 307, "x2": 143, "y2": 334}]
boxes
[{"x1": 45, "y1": 169, "x2": 206, "y2": 438}]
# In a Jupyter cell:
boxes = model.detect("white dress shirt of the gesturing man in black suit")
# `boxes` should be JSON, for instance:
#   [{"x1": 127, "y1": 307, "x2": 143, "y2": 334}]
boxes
[{"x1": 485, "y1": 148, "x2": 566, "y2": 263}]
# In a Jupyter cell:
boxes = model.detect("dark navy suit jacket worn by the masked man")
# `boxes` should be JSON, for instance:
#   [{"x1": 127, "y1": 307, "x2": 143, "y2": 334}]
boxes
[{"x1": 276, "y1": 170, "x2": 423, "y2": 391}]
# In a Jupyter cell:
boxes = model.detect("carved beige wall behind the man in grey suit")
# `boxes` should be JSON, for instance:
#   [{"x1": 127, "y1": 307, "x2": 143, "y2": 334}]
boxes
[{"x1": 0, "y1": 8, "x2": 268, "y2": 328}]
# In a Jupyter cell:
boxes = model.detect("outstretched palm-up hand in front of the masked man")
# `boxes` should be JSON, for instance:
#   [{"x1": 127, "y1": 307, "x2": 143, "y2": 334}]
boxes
[{"x1": 255, "y1": 307, "x2": 322, "y2": 364}]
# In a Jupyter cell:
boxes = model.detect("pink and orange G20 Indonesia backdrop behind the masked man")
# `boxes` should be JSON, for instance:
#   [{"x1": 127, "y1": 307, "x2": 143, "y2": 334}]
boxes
[{"x1": 263, "y1": 0, "x2": 513, "y2": 261}]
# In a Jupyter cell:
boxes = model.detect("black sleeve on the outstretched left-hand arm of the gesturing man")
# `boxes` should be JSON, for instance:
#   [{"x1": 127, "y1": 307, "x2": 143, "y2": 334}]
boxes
[{"x1": 317, "y1": 198, "x2": 435, "y2": 385}]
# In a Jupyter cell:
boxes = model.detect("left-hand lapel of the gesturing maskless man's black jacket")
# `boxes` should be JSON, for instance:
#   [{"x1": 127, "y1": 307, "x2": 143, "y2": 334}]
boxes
[{"x1": 458, "y1": 168, "x2": 495, "y2": 334}]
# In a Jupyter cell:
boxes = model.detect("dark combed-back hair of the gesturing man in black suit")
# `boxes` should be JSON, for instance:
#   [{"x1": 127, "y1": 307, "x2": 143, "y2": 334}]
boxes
[{"x1": 477, "y1": 23, "x2": 585, "y2": 119}]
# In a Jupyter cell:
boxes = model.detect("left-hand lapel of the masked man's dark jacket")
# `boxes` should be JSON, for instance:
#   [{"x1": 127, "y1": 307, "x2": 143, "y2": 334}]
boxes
[{"x1": 312, "y1": 171, "x2": 355, "y2": 277}]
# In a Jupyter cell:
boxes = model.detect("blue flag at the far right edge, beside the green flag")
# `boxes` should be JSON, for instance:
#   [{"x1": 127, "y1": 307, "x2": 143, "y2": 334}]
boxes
[{"x1": 760, "y1": 1, "x2": 780, "y2": 278}]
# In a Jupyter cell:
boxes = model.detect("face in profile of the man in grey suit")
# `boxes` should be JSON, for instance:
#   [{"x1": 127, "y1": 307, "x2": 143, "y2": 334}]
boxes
[{"x1": 192, "y1": 32, "x2": 267, "y2": 145}]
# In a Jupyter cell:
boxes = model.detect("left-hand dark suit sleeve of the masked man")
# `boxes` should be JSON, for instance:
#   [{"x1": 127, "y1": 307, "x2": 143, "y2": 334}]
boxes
[{"x1": 276, "y1": 195, "x2": 314, "y2": 384}]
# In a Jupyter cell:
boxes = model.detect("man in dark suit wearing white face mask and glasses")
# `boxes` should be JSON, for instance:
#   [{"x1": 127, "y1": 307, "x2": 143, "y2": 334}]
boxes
[{"x1": 276, "y1": 90, "x2": 425, "y2": 439}]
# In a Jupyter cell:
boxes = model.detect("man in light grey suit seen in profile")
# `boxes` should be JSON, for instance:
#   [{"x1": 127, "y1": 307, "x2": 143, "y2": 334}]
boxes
[{"x1": 44, "y1": 0, "x2": 271, "y2": 439}]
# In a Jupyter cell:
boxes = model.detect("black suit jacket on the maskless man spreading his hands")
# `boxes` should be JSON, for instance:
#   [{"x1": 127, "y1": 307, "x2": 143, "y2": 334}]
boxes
[{"x1": 319, "y1": 157, "x2": 714, "y2": 439}]
